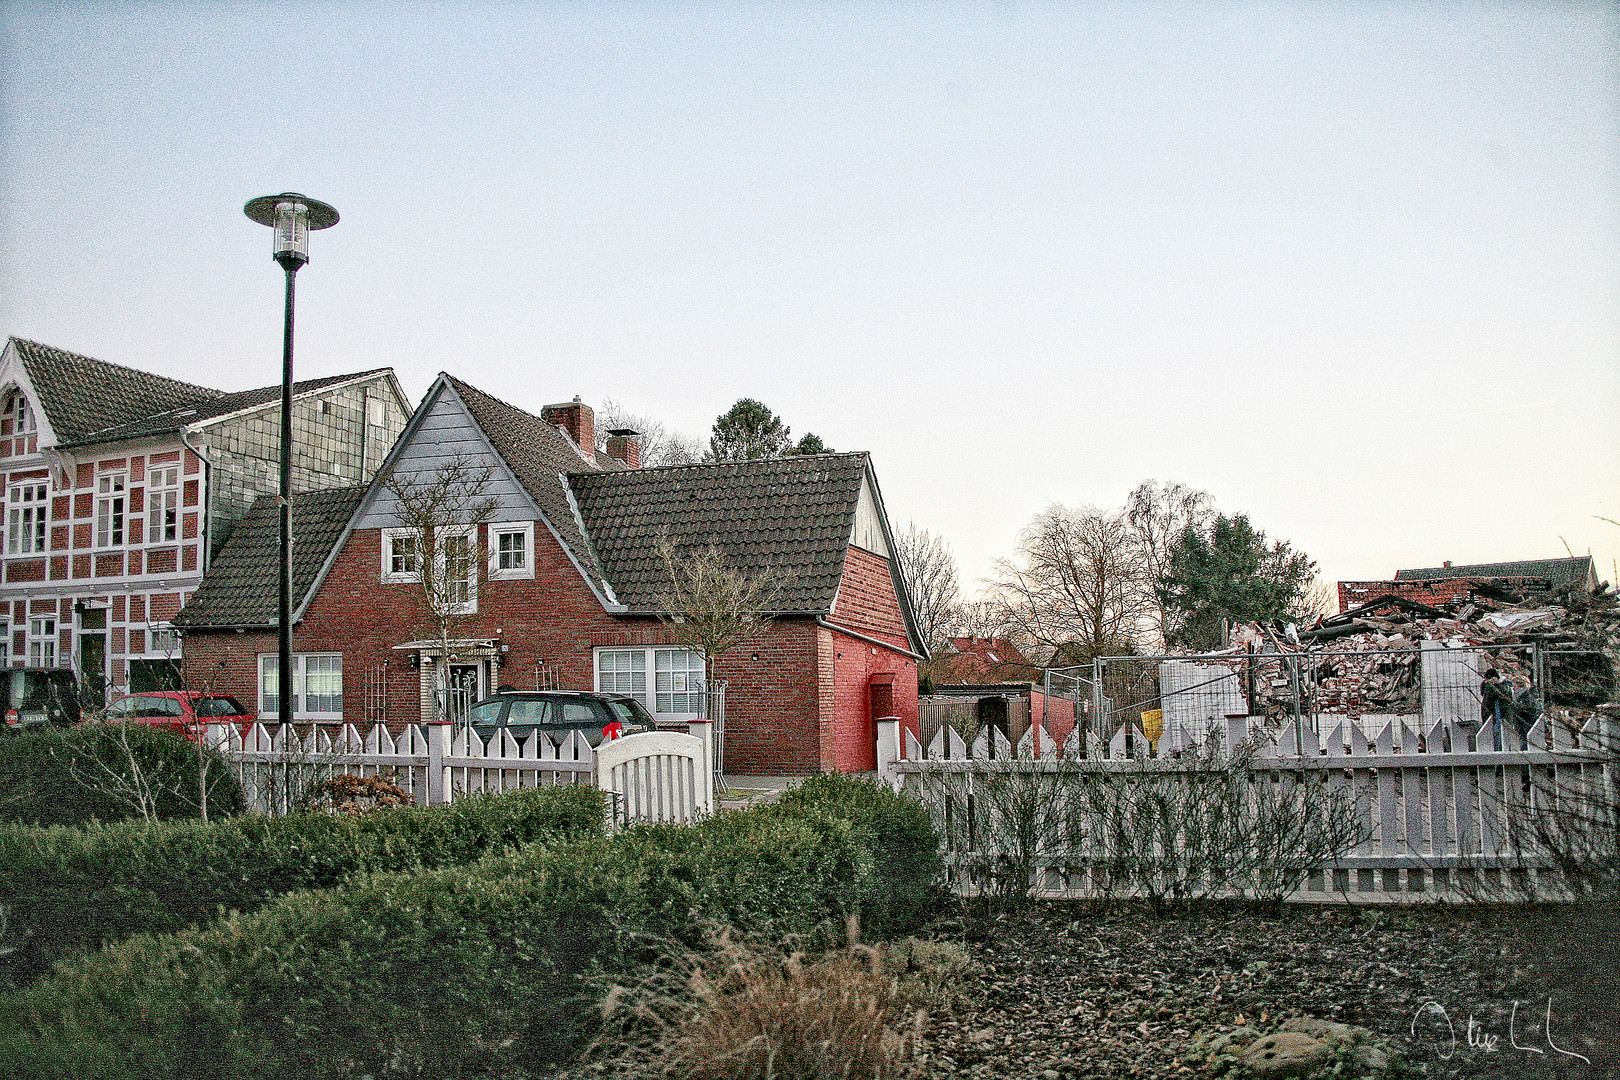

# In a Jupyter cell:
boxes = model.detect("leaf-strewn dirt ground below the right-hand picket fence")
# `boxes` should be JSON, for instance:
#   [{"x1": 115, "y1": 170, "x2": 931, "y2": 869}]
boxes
[{"x1": 922, "y1": 902, "x2": 1620, "y2": 1080}]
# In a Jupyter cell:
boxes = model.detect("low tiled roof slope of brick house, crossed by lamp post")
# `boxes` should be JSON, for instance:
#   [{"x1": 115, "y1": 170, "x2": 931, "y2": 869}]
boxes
[{"x1": 175, "y1": 486, "x2": 366, "y2": 628}]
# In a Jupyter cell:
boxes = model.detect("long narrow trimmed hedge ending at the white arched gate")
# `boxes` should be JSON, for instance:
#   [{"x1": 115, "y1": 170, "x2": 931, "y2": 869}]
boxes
[{"x1": 0, "y1": 785, "x2": 603, "y2": 984}]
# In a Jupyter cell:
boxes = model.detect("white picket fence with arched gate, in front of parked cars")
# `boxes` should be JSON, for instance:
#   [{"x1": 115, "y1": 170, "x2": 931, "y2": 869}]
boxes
[{"x1": 209, "y1": 722, "x2": 714, "y2": 824}]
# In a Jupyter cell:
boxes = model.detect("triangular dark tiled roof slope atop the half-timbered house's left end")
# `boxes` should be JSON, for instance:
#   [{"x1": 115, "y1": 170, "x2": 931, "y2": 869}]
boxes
[{"x1": 11, "y1": 338, "x2": 225, "y2": 445}]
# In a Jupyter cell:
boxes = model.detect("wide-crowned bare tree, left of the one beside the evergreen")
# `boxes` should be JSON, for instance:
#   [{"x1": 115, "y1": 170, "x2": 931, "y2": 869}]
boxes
[{"x1": 991, "y1": 504, "x2": 1150, "y2": 664}]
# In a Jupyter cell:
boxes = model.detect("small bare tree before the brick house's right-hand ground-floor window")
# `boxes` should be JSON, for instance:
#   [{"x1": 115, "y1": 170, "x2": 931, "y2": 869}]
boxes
[{"x1": 653, "y1": 533, "x2": 782, "y2": 690}]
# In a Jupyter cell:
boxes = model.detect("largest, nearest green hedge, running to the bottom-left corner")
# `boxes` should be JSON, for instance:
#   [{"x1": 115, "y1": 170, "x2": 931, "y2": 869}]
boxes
[{"x1": 0, "y1": 787, "x2": 932, "y2": 1080}]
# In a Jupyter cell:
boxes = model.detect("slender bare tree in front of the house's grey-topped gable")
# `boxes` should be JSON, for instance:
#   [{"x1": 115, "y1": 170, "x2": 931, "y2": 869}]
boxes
[{"x1": 382, "y1": 457, "x2": 499, "y2": 719}]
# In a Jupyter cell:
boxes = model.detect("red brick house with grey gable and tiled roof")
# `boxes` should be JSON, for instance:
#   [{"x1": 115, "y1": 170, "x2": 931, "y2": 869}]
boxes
[{"x1": 175, "y1": 376, "x2": 925, "y2": 774}]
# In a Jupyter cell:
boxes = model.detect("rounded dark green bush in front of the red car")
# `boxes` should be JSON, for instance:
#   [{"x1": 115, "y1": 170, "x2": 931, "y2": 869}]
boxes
[{"x1": 0, "y1": 724, "x2": 243, "y2": 826}]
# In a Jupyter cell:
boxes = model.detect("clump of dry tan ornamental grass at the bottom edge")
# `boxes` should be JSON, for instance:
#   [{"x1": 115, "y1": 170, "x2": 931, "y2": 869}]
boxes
[{"x1": 595, "y1": 921, "x2": 964, "y2": 1080}]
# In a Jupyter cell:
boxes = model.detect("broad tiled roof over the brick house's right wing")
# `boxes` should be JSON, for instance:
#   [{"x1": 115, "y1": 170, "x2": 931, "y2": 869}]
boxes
[{"x1": 569, "y1": 453, "x2": 867, "y2": 614}]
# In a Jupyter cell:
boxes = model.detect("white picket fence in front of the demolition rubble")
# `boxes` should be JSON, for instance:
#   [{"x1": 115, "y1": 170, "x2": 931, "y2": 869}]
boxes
[{"x1": 878, "y1": 711, "x2": 1620, "y2": 902}]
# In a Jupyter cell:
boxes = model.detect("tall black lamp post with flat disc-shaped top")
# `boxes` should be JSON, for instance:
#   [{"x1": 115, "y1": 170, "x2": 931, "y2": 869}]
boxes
[{"x1": 241, "y1": 191, "x2": 337, "y2": 724}]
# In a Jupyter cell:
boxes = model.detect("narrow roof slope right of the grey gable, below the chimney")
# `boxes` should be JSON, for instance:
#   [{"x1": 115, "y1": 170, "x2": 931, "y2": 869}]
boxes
[{"x1": 444, "y1": 374, "x2": 601, "y2": 583}]
